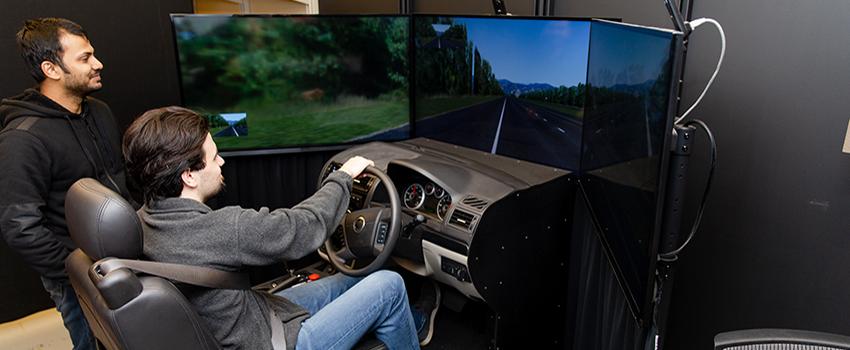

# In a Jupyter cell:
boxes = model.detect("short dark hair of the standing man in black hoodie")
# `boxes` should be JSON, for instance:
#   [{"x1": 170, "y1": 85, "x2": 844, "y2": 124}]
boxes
[{"x1": 17, "y1": 17, "x2": 88, "y2": 83}]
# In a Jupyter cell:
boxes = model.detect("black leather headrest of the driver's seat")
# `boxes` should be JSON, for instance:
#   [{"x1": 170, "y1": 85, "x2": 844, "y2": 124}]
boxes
[{"x1": 65, "y1": 178, "x2": 143, "y2": 260}]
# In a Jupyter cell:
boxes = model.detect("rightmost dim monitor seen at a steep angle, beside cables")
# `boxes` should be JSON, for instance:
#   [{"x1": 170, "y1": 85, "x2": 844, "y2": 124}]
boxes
[{"x1": 580, "y1": 21, "x2": 682, "y2": 318}]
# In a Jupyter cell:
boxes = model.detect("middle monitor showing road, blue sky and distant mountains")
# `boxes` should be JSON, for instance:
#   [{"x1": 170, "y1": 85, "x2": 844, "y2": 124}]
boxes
[{"x1": 413, "y1": 16, "x2": 591, "y2": 170}]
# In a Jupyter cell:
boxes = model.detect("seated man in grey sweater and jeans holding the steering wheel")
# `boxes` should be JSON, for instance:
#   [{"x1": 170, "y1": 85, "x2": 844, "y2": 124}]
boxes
[{"x1": 123, "y1": 107, "x2": 438, "y2": 350}]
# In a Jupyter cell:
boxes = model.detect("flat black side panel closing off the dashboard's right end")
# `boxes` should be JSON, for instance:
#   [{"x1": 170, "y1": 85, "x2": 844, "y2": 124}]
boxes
[{"x1": 469, "y1": 176, "x2": 576, "y2": 349}]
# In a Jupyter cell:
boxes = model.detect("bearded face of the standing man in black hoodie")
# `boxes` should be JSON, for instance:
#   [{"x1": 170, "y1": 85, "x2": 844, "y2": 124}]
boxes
[{"x1": 59, "y1": 32, "x2": 103, "y2": 97}]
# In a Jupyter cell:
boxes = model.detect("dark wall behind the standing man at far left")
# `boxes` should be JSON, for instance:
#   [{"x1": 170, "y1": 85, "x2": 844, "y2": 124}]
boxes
[{"x1": 0, "y1": 0, "x2": 192, "y2": 322}]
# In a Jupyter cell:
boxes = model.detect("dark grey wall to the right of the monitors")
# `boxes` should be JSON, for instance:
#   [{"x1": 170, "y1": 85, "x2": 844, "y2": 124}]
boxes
[{"x1": 555, "y1": 0, "x2": 850, "y2": 349}]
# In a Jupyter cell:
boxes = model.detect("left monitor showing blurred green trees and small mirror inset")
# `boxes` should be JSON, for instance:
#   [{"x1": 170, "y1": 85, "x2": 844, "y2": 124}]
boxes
[{"x1": 172, "y1": 15, "x2": 410, "y2": 153}]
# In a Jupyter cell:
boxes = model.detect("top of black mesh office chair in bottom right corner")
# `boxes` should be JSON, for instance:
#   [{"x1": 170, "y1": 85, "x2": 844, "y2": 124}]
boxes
[{"x1": 714, "y1": 328, "x2": 850, "y2": 350}]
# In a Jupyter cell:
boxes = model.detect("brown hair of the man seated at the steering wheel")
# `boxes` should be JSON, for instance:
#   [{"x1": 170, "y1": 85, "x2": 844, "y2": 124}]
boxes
[{"x1": 123, "y1": 106, "x2": 209, "y2": 203}]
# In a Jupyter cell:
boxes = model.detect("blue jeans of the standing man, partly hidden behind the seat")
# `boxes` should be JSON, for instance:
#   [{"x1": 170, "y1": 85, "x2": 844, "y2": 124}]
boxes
[{"x1": 41, "y1": 277, "x2": 97, "y2": 350}]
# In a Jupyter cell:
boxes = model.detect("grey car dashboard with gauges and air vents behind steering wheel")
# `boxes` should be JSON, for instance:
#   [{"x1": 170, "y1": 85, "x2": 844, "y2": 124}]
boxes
[{"x1": 319, "y1": 138, "x2": 571, "y2": 303}]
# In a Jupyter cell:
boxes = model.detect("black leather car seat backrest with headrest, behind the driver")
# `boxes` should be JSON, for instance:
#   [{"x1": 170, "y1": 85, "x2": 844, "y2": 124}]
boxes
[{"x1": 65, "y1": 178, "x2": 220, "y2": 349}]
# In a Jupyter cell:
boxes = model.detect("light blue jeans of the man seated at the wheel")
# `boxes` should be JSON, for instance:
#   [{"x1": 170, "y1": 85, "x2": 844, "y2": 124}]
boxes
[{"x1": 277, "y1": 270, "x2": 419, "y2": 350}]
